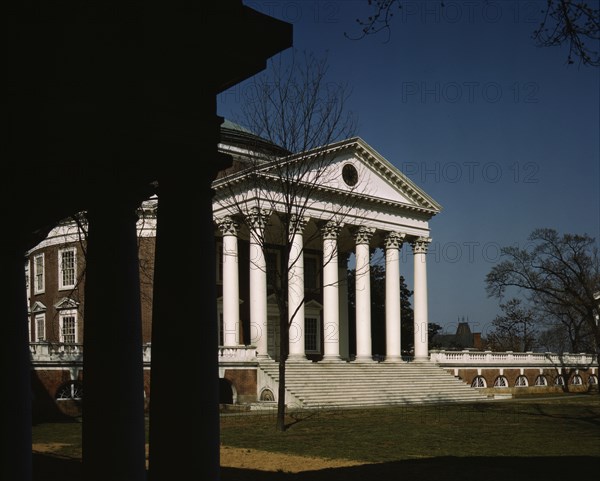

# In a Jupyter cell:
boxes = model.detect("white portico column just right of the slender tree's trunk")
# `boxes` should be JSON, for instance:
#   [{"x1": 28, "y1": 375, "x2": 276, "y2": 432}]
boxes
[{"x1": 288, "y1": 216, "x2": 308, "y2": 361}]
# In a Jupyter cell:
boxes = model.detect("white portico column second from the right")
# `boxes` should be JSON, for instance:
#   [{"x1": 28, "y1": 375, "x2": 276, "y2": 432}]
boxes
[{"x1": 385, "y1": 232, "x2": 404, "y2": 362}]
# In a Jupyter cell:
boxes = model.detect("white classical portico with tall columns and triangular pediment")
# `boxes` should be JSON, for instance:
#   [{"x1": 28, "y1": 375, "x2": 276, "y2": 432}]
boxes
[{"x1": 213, "y1": 134, "x2": 440, "y2": 363}]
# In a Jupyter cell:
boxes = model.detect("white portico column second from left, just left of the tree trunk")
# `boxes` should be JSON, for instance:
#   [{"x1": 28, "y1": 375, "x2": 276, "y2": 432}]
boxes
[{"x1": 247, "y1": 207, "x2": 269, "y2": 358}]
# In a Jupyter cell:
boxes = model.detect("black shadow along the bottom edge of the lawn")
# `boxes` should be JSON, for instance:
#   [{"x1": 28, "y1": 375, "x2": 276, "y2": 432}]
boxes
[{"x1": 221, "y1": 456, "x2": 600, "y2": 481}]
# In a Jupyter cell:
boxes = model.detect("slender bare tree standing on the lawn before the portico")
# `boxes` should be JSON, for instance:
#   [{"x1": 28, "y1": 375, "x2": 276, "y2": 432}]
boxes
[{"x1": 214, "y1": 52, "x2": 356, "y2": 431}]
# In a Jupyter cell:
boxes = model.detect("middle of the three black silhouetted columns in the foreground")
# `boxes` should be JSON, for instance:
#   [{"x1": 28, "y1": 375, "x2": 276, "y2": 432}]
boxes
[{"x1": 82, "y1": 198, "x2": 146, "y2": 481}]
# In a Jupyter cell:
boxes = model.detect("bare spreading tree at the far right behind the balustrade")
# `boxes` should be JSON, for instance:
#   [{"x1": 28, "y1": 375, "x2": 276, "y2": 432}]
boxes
[{"x1": 486, "y1": 229, "x2": 600, "y2": 362}]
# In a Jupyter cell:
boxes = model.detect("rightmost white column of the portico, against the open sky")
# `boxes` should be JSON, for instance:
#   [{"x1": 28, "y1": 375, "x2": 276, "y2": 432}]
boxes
[{"x1": 411, "y1": 237, "x2": 431, "y2": 361}]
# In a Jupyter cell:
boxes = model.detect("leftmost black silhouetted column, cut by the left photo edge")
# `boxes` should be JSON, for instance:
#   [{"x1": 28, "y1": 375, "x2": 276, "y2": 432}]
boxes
[{"x1": 0, "y1": 246, "x2": 32, "y2": 481}]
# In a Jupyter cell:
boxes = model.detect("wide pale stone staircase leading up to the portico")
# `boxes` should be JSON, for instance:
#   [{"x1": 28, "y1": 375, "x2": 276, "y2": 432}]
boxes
[{"x1": 259, "y1": 360, "x2": 489, "y2": 408}]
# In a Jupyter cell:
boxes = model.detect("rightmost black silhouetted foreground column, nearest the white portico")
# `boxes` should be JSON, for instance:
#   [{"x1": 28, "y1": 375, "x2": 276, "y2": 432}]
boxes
[{"x1": 149, "y1": 119, "x2": 227, "y2": 481}]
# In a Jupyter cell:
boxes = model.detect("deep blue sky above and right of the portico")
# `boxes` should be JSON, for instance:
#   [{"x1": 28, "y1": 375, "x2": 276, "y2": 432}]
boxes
[{"x1": 218, "y1": 0, "x2": 600, "y2": 333}]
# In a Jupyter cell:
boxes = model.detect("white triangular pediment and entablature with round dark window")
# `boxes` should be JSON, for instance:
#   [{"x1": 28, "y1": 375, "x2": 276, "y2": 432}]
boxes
[{"x1": 213, "y1": 137, "x2": 441, "y2": 237}]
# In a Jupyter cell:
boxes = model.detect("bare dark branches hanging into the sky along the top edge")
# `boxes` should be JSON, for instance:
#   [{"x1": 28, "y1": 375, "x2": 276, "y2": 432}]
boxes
[{"x1": 346, "y1": 0, "x2": 600, "y2": 67}]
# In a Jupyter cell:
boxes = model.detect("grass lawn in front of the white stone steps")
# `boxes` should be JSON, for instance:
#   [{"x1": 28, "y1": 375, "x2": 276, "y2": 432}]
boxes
[{"x1": 33, "y1": 395, "x2": 600, "y2": 481}]
